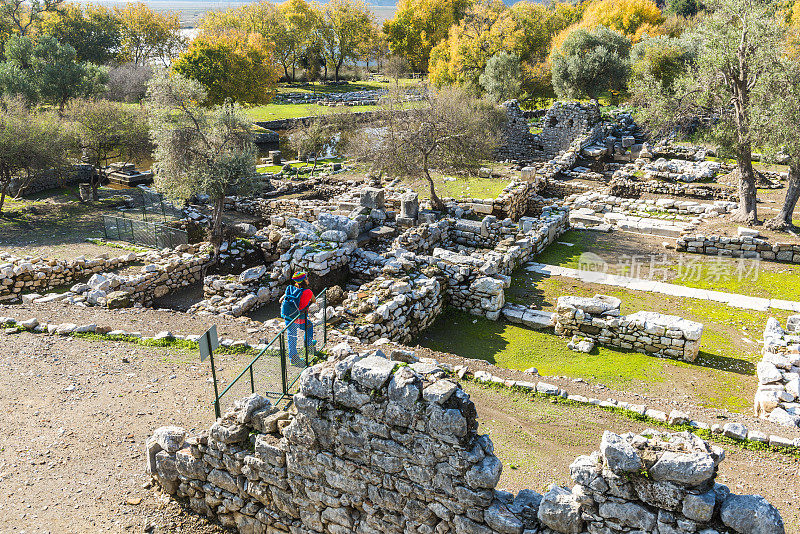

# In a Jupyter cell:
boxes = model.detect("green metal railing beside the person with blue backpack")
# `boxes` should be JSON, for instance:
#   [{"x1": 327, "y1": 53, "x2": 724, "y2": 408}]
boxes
[{"x1": 213, "y1": 289, "x2": 328, "y2": 417}]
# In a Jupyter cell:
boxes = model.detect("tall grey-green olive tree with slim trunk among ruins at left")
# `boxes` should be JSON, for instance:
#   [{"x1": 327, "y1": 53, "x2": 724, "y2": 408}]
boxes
[{"x1": 148, "y1": 72, "x2": 260, "y2": 255}]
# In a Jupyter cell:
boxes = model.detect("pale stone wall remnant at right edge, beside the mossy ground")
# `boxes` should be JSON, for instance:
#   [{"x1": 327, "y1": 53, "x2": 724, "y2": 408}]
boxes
[{"x1": 753, "y1": 315, "x2": 800, "y2": 427}]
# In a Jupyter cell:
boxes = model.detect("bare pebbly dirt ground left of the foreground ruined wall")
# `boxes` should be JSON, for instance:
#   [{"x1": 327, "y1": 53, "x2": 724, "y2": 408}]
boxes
[{"x1": 0, "y1": 334, "x2": 228, "y2": 533}]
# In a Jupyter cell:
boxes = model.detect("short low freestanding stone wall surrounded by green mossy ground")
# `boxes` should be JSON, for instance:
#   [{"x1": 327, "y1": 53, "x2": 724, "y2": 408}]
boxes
[{"x1": 555, "y1": 295, "x2": 703, "y2": 362}]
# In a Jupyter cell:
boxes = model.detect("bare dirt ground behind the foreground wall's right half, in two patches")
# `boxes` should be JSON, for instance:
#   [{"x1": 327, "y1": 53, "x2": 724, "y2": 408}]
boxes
[{"x1": 462, "y1": 383, "x2": 800, "y2": 534}]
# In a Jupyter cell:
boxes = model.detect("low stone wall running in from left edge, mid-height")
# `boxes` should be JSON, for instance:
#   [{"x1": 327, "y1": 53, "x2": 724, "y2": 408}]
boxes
[{"x1": 0, "y1": 253, "x2": 138, "y2": 301}]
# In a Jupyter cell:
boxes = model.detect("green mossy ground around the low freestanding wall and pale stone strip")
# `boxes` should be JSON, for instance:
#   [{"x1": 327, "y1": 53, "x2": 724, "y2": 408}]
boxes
[{"x1": 419, "y1": 232, "x2": 800, "y2": 411}]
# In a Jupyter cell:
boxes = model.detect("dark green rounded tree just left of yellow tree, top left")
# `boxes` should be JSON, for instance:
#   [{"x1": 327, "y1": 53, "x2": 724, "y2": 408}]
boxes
[{"x1": 42, "y1": 4, "x2": 122, "y2": 65}]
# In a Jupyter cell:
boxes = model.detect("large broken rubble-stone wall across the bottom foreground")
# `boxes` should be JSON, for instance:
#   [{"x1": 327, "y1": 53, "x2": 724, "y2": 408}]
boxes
[{"x1": 146, "y1": 347, "x2": 784, "y2": 534}]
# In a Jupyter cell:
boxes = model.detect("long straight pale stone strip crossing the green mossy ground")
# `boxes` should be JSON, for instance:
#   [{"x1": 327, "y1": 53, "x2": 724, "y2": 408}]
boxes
[{"x1": 525, "y1": 262, "x2": 800, "y2": 312}]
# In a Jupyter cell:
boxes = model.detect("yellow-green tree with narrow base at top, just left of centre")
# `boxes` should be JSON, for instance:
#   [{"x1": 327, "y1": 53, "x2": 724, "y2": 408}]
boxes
[{"x1": 318, "y1": 0, "x2": 373, "y2": 81}]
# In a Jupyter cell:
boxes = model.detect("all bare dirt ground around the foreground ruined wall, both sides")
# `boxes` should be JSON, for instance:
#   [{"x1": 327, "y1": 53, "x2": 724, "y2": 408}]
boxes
[{"x1": 0, "y1": 333, "x2": 800, "y2": 533}]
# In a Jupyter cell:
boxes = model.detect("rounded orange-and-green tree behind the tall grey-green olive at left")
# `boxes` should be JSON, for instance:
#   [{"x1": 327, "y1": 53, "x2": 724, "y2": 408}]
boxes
[{"x1": 172, "y1": 32, "x2": 278, "y2": 105}]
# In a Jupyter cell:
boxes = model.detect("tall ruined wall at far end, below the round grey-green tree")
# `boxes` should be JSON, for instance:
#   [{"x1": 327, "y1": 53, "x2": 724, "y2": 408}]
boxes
[{"x1": 539, "y1": 102, "x2": 600, "y2": 157}]
